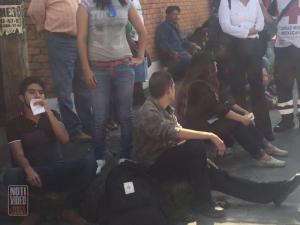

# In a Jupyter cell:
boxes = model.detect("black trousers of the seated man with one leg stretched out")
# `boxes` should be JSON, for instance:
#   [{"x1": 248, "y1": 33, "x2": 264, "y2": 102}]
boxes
[{"x1": 149, "y1": 140, "x2": 282, "y2": 204}]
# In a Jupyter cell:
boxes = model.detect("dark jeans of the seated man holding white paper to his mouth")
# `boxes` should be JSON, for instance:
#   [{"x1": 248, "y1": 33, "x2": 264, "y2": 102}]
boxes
[{"x1": 3, "y1": 158, "x2": 96, "y2": 209}]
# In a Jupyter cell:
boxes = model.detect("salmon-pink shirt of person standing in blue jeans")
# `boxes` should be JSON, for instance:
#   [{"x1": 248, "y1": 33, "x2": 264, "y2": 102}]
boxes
[{"x1": 27, "y1": 0, "x2": 80, "y2": 35}]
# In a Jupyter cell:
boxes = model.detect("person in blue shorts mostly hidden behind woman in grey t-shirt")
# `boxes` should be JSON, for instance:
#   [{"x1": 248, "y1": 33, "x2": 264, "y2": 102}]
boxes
[{"x1": 126, "y1": 0, "x2": 148, "y2": 106}]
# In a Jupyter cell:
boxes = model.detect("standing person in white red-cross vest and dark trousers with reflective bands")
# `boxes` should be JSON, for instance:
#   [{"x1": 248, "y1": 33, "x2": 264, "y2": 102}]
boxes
[{"x1": 274, "y1": 0, "x2": 300, "y2": 132}]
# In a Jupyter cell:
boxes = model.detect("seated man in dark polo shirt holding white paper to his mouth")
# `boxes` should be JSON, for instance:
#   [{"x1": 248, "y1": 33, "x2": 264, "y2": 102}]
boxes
[{"x1": 3, "y1": 77, "x2": 96, "y2": 225}]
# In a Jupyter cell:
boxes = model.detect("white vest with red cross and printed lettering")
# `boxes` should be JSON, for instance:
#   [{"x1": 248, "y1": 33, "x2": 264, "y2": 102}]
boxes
[{"x1": 275, "y1": 0, "x2": 300, "y2": 48}]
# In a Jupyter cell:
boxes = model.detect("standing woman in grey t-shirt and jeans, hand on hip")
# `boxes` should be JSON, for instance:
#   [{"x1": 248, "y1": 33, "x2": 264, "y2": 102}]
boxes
[{"x1": 77, "y1": 0, "x2": 146, "y2": 173}]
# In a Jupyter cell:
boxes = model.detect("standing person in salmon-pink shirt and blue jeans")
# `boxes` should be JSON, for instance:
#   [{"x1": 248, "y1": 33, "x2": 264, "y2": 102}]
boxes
[{"x1": 28, "y1": 0, "x2": 92, "y2": 142}]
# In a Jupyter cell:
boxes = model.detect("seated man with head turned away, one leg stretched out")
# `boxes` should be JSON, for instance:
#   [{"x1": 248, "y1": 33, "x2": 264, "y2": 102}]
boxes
[{"x1": 135, "y1": 71, "x2": 300, "y2": 217}]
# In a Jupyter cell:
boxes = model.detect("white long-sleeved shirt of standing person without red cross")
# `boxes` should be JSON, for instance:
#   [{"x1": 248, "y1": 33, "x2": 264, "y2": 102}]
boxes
[{"x1": 219, "y1": 0, "x2": 265, "y2": 38}]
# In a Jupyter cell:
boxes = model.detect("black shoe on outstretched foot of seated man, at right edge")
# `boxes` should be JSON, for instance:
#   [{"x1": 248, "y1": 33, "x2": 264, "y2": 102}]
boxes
[{"x1": 273, "y1": 173, "x2": 300, "y2": 207}]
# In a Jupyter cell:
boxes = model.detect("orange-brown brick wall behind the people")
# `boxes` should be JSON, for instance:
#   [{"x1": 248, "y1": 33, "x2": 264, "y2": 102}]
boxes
[{"x1": 25, "y1": 0, "x2": 209, "y2": 95}]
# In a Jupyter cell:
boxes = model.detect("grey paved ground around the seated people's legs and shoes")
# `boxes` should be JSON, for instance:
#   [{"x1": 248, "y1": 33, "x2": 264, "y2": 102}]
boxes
[{"x1": 0, "y1": 107, "x2": 300, "y2": 225}]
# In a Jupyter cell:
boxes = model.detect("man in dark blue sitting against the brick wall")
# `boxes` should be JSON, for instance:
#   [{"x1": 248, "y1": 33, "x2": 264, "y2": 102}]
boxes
[{"x1": 156, "y1": 6, "x2": 200, "y2": 77}]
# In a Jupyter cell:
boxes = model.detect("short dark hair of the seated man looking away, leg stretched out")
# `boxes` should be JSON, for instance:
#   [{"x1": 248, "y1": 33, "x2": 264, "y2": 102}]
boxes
[{"x1": 149, "y1": 71, "x2": 174, "y2": 99}]
